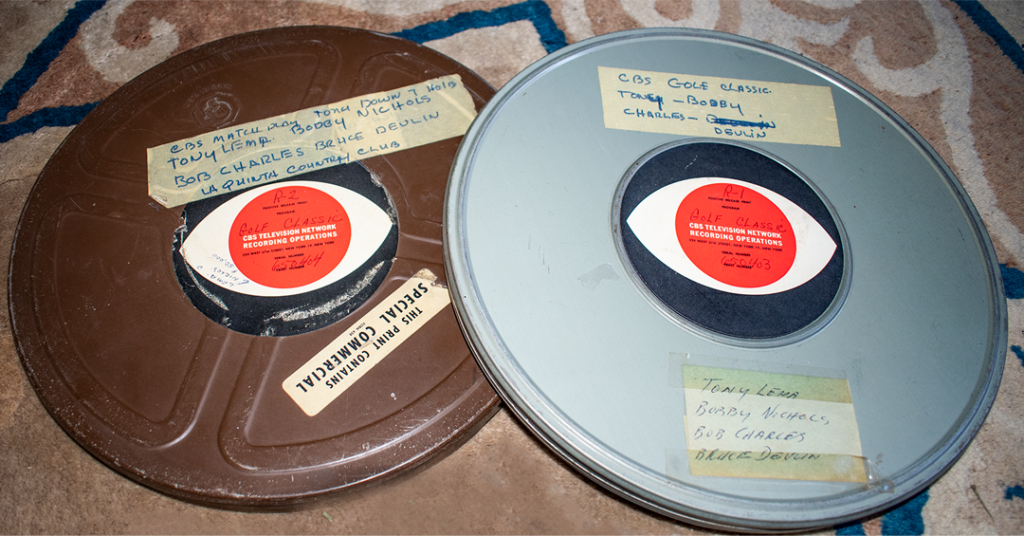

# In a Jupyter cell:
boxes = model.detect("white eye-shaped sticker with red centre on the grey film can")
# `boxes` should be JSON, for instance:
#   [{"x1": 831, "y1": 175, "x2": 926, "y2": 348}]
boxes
[{"x1": 627, "y1": 177, "x2": 837, "y2": 295}]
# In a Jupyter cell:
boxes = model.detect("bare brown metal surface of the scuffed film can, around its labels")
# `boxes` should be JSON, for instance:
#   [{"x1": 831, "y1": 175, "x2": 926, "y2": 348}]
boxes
[{"x1": 9, "y1": 27, "x2": 498, "y2": 508}]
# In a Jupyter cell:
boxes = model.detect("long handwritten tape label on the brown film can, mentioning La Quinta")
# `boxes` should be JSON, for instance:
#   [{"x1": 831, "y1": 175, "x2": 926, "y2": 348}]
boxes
[{"x1": 146, "y1": 75, "x2": 476, "y2": 207}]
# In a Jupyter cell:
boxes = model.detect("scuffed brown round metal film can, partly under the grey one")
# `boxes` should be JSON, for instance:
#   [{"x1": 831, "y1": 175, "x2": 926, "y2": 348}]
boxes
[{"x1": 10, "y1": 27, "x2": 499, "y2": 507}]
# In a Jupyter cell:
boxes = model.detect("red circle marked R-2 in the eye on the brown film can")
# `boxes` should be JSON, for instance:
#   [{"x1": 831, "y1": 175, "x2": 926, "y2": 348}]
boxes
[{"x1": 228, "y1": 185, "x2": 352, "y2": 288}]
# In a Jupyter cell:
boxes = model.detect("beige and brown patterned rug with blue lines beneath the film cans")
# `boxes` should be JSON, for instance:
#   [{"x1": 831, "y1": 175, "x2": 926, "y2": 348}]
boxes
[{"x1": 0, "y1": 0, "x2": 1024, "y2": 536}]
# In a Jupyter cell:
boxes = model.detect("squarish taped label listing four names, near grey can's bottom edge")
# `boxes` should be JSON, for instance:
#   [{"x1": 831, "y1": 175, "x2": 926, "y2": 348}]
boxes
[{"x1": 683, "y1": 365, "x2": 866, "y2": 483}]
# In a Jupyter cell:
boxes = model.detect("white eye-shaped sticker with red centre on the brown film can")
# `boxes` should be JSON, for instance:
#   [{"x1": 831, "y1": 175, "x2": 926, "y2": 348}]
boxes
[{"x1": 181, "y1": 180, "x2": 393, "y2": 297}]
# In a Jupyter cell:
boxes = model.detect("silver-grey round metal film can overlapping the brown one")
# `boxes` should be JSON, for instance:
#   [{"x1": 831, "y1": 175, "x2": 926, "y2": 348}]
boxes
[{"x1": 444, "y1": 30, "x2": 1007, "y2": 531}]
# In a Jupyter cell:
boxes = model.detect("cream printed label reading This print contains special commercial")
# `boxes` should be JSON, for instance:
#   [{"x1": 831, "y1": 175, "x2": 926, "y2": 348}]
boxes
[{"x1": 281, "y1": 269, "x2": 451, "y2": 417}]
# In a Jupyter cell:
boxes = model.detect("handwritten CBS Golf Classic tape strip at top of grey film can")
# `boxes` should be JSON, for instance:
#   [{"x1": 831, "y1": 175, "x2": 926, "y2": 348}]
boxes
[{"x1": 597, "y1": 67, "x2": 840, "y2": 147}]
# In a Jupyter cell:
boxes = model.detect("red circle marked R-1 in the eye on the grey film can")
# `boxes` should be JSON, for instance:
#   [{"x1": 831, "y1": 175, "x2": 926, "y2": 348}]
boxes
[{"x1": 676, "y1": 182, "x2": 797, "y2": 288}]
